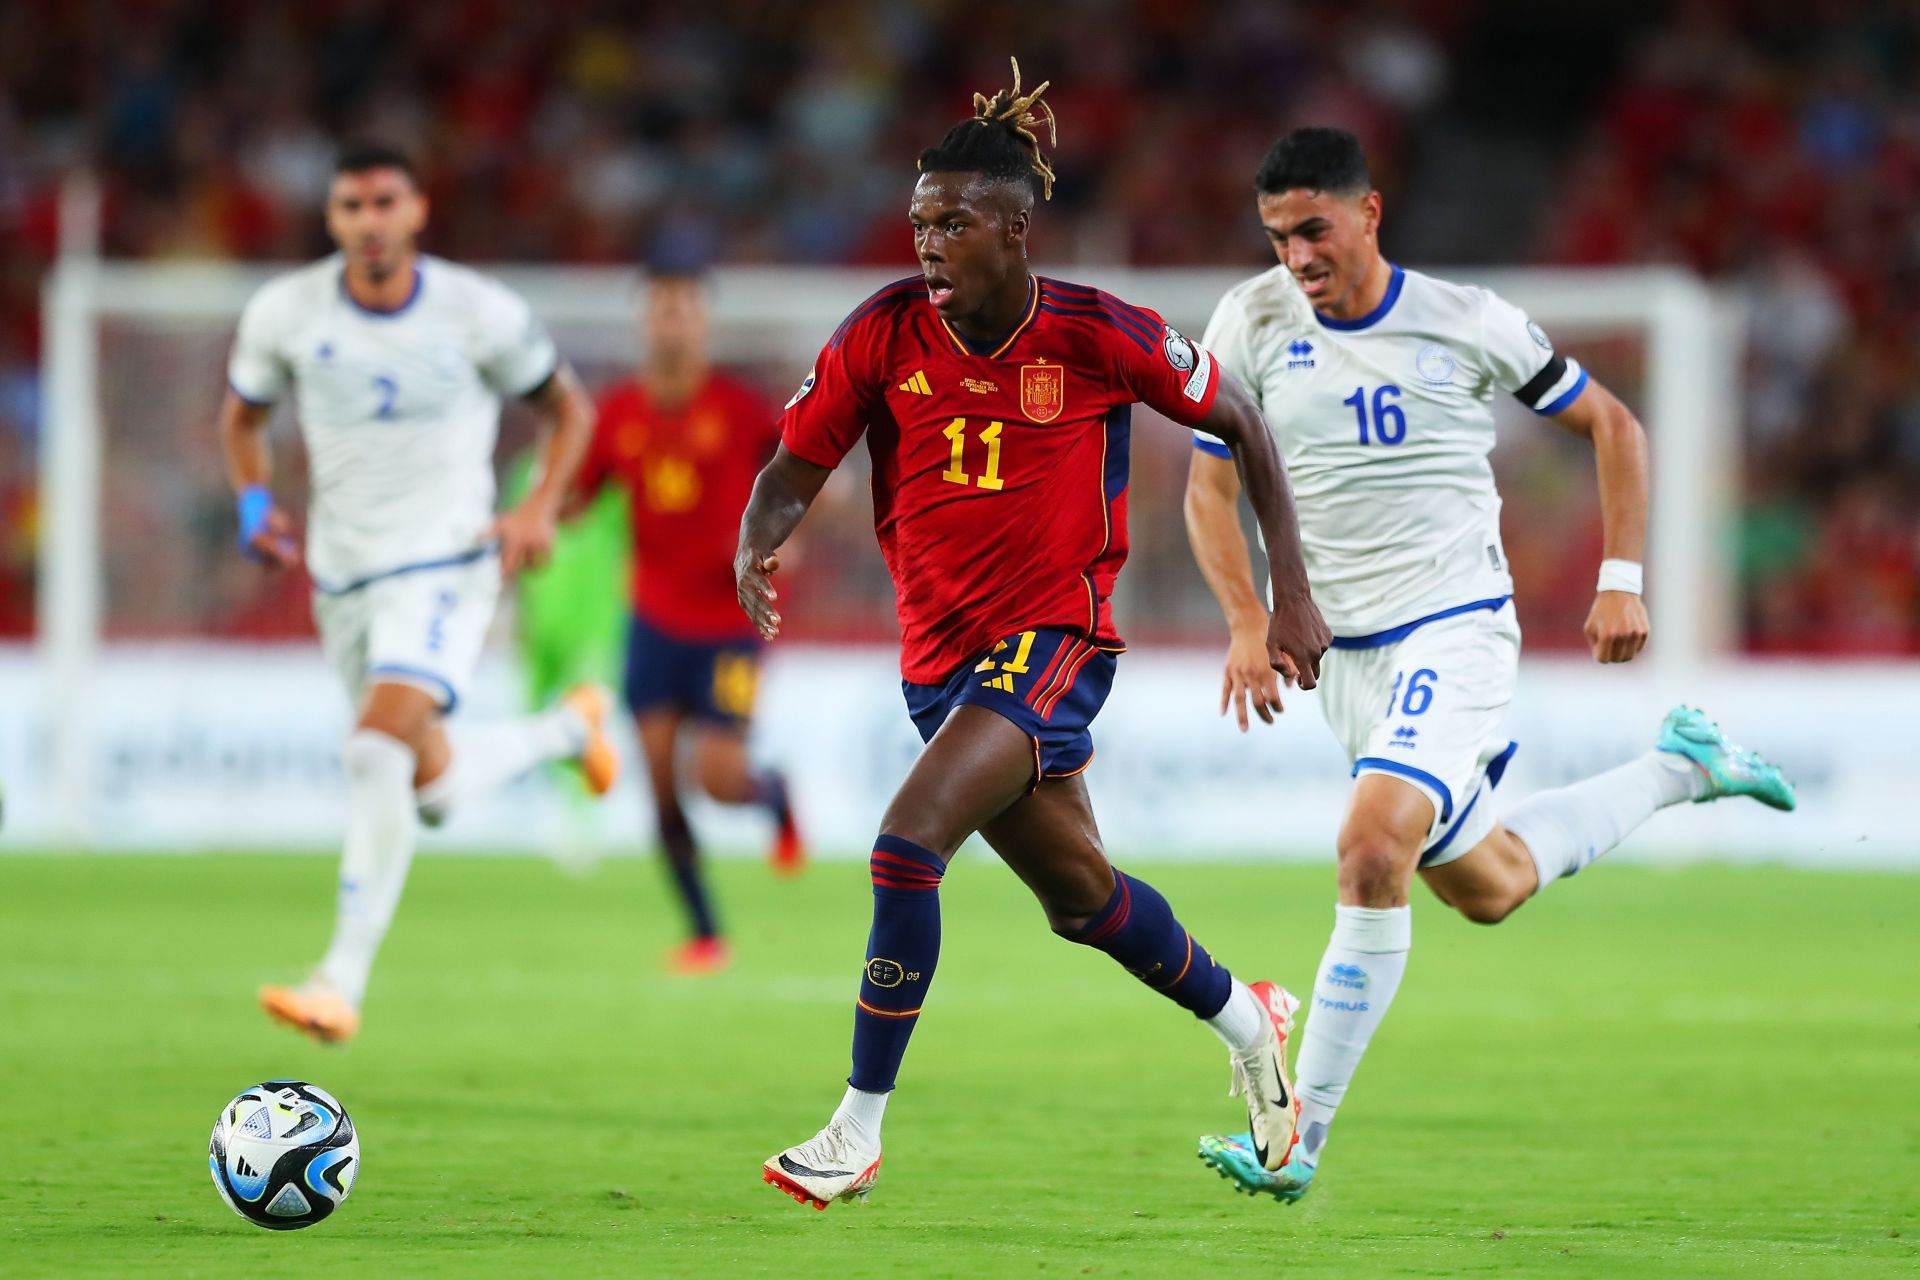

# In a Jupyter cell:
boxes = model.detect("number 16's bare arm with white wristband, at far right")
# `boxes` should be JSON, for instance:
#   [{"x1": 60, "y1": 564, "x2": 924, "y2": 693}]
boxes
[{"x1": 1553, "y1": 382, "x2": 1647, "y2": 662}]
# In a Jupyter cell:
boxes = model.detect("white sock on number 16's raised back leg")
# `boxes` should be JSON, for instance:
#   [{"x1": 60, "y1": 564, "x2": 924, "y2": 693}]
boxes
[{"x1": 1501, "y1": 750, "x2": 1707, "y2": 892}]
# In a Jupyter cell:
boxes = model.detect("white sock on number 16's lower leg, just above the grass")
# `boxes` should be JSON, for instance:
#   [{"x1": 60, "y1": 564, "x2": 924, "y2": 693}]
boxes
[{"x1": 1294, "y1": 906, "x2": 1413, "y2": 1163}]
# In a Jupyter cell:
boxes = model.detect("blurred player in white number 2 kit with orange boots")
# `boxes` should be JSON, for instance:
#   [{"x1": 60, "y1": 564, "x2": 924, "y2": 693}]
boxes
[{"x1": 221, "y1": 144, "x2": 618, "y2": 1040}]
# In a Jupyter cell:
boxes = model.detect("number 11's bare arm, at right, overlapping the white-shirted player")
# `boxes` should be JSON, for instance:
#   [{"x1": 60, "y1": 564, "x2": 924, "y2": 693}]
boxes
[{"x1": 1196, "y1": 378, "x2": 1332, "y2": 710}]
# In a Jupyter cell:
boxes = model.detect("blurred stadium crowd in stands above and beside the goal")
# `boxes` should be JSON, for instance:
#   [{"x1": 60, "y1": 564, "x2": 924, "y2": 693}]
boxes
[{"x1": 0, "y1": 0, "x2": 1920, "y2": 654}]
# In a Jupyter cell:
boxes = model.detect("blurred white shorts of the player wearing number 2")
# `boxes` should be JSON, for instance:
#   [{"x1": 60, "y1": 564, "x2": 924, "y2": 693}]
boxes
[{"x1": 313, "y1": 553, "x2": 499, "y2": 712}]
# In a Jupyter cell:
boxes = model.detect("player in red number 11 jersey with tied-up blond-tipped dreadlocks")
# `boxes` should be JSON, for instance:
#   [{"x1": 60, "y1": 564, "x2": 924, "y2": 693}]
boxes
[{"x1": 733, "y1": 65, "x2": 1329, "y2": 1209}]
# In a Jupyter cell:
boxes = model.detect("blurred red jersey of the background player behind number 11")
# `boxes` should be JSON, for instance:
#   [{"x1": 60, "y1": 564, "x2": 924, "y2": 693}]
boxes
[{"x1": 578, "y1": 372, "x2": 776, "y2": 641}]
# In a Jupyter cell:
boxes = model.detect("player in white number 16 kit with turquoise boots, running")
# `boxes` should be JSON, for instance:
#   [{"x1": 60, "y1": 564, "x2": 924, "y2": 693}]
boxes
[{"x1": 1187, "y1": 129, "x2": 1793, "y2": 1201}]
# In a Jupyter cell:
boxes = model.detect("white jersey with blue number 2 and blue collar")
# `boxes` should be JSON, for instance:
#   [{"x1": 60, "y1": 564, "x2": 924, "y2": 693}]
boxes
[{"x1": 227, "y1": 255, "x2": 559, "y2": 593}]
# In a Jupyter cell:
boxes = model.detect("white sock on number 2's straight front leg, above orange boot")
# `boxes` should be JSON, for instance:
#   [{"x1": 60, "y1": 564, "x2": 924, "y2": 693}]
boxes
[{"x1": 321, "y1": 729, "x2": 415, "y2": 1007}]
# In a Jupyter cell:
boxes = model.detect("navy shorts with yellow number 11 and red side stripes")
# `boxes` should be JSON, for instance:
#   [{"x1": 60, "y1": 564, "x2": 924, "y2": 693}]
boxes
[{"x1": 900, "y1": 628, "x2": 1119, "y2": 781}]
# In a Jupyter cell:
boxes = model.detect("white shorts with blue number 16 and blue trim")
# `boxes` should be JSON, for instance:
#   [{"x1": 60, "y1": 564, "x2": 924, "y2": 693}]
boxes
[{"x1": 1319, "y1": 601, "x2": 1521, "y2": 867}]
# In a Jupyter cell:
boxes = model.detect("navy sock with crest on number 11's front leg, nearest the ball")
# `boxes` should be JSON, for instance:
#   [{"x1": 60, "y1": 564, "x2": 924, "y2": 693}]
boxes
[{"x1": 847, "y1": 835, "x2": 947, "y2": 1094}]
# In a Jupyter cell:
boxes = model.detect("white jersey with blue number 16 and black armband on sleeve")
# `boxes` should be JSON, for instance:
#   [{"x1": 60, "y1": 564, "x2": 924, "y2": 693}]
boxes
[{"x1": 1194, "y1": 267, "x2": 1586, "y2": 639}]
